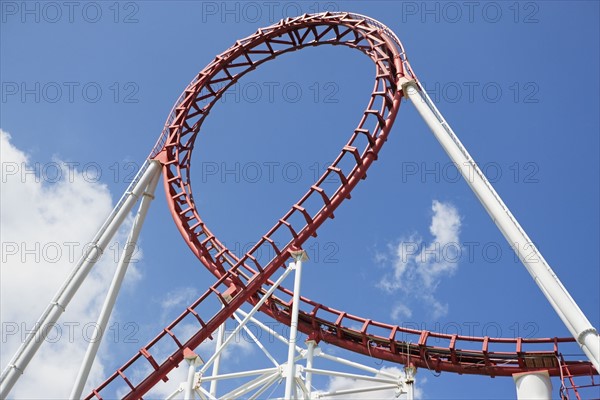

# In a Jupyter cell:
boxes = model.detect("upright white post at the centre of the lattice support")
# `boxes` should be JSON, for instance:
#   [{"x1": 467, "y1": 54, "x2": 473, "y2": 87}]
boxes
[{"x1": 284, "y1": 250, "x2": 308, "y2": 400}]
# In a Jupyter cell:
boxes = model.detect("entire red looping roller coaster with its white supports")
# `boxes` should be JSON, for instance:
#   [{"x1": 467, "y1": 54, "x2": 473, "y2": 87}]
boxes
[{"x1": 0, "y1": 12, "x2": 600, "y2": 399}]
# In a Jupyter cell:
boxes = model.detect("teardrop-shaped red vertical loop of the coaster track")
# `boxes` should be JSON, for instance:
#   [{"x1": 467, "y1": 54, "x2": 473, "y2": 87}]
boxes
[{"x1": 152, "y1": 13, "x2": 408, "y2": 284}]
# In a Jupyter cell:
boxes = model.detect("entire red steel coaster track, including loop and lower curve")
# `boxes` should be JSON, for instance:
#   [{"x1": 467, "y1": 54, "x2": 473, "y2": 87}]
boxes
[{"x1": 87, "y1": 13, "x2": 597, "y2": 399}]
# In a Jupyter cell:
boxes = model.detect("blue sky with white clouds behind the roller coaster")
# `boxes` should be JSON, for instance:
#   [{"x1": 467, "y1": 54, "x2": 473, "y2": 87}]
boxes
[{"x1": 0, "y1": 1, "x2": 600, "y2": 399}]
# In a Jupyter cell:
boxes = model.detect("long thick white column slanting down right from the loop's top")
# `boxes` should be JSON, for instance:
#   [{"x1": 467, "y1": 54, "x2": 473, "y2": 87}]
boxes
[{"x1": 403, "y1": 81, "x2": 600, "y2": 371}]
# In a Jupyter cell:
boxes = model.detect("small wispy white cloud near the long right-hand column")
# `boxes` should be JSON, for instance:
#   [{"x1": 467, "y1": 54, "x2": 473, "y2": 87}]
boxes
[{"x1": 377, "y1": 200, "x2": 461, "y2": 320}]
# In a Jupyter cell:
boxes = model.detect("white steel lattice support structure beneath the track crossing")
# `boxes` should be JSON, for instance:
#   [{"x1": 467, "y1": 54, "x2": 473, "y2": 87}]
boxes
[{"x1": 167, "y1": 255, "x2": 416, "y2": 400}]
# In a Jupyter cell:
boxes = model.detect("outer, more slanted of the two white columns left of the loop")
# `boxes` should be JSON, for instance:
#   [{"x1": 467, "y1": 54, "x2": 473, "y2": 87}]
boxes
[{"x1": 0, "y1": 160, "x2": 161, "y2": 399}]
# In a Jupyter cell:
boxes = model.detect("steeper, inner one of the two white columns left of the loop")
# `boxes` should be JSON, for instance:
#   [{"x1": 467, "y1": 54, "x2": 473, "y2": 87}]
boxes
[{"x1": 70, "y1": 167, "x2": 160, "y2": 400}]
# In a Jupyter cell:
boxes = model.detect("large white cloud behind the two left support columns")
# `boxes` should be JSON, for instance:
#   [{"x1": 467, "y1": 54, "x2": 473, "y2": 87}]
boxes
[{"x1": 0, "y1": 130, "x2": 140, "y2": 399}]
